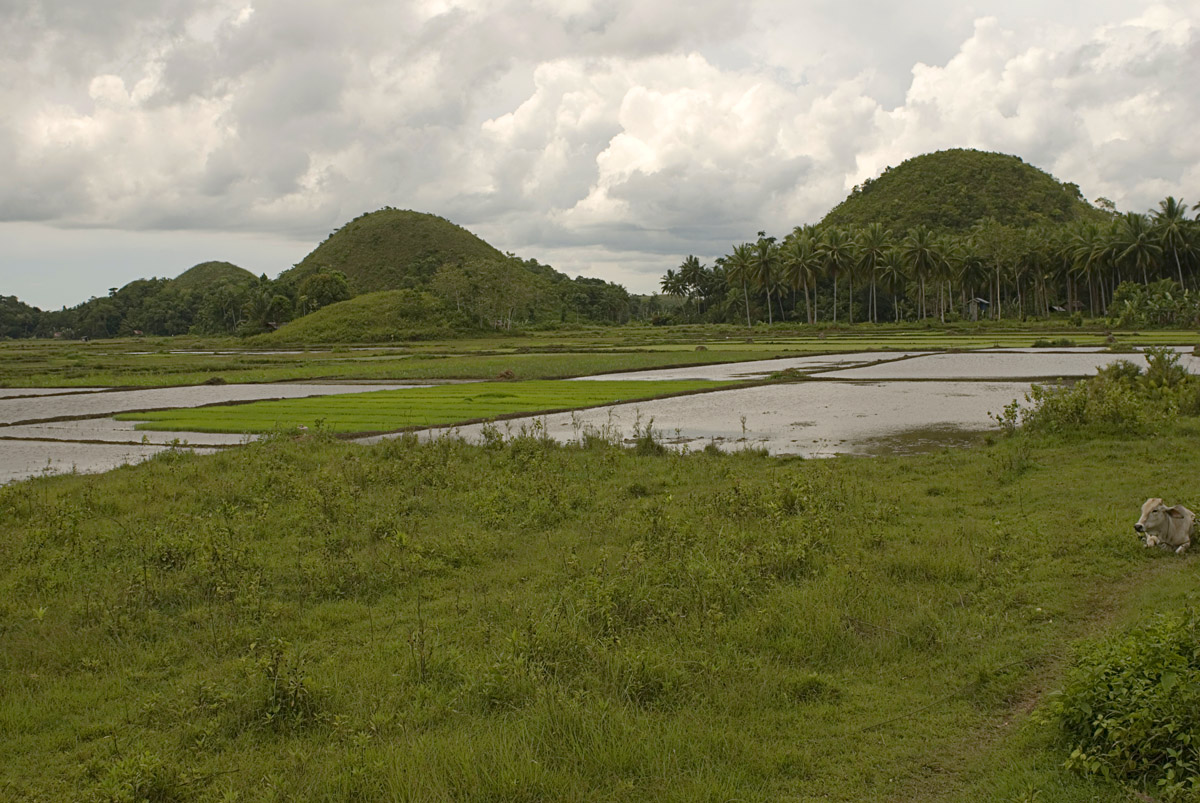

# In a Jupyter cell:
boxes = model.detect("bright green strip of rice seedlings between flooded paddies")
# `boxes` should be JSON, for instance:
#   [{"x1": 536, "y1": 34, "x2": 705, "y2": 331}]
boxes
[{"x1": 116, "y1": 380, "x2": 737, "y2": 433}]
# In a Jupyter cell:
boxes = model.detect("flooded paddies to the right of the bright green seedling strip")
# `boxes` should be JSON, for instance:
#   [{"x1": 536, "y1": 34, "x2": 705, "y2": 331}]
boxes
[{"x1": 374, "y1": 348, "x2": 1200, "y2": 457}]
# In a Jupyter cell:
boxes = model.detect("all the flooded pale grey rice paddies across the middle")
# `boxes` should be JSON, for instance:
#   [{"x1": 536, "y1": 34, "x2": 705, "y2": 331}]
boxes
[{"x1": 0, "y1": 348, "x2": 1200, "y2": 484}]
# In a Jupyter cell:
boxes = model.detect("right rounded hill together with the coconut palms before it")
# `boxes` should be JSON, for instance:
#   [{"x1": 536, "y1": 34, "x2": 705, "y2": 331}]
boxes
[{"x1": 661, "y1": 150, "x2": 1200, "y2": 325}]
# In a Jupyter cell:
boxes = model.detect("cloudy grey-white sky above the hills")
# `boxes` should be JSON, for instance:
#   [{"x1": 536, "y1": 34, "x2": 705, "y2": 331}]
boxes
[{"x1": 0, "y1": 0, "x2": 1200, "y2": 308}]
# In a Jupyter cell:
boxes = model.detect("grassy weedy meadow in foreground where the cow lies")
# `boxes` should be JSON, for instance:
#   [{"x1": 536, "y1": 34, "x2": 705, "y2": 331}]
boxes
[{"x1": 0, "y1": 425, "x2": 1200, "y2": 802}]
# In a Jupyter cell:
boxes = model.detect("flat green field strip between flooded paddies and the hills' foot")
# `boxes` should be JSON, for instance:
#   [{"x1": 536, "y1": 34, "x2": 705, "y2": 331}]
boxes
[{"x1": 0, "y1": 324, "x2": 1200, "y2": 388}]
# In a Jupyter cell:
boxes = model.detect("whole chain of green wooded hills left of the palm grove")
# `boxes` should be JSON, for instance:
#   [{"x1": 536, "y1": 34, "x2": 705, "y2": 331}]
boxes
[{"x1": 0, "y1": 209, "x2": 659, "y2": 342}]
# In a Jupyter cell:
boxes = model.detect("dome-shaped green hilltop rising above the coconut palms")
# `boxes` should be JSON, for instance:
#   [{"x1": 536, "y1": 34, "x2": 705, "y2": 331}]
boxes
[{"x1": 821, "y1": 149, "x2": 1105, "y2": 232}]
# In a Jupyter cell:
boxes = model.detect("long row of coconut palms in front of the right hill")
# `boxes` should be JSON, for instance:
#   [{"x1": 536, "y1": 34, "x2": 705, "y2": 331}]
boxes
[{"x1": 660, "y1": 197, "x2": 1200, "y2": 326}]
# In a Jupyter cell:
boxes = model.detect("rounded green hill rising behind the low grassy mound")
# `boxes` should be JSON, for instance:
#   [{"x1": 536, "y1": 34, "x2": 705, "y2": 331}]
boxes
[{"x1": 280, "y1": 208, "x2": 504, "y2": 294}]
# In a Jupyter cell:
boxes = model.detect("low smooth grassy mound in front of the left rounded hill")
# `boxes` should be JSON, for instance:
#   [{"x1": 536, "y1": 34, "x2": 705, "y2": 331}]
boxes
[{"x1": 251, "y1": 289, "x2": 456, "y2": 346}]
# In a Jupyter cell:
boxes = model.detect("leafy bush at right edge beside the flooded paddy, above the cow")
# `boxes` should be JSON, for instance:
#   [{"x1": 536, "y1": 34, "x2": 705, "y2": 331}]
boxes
[{"x1": 992, "y1": 348, "x2": 1200, "y2": 435}]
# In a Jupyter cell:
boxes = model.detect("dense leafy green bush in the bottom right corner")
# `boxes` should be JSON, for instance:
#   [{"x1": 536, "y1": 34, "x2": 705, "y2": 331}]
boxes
[{"x1": 1051, "y1": 609, "x2": 1200, "y2": 801}]
